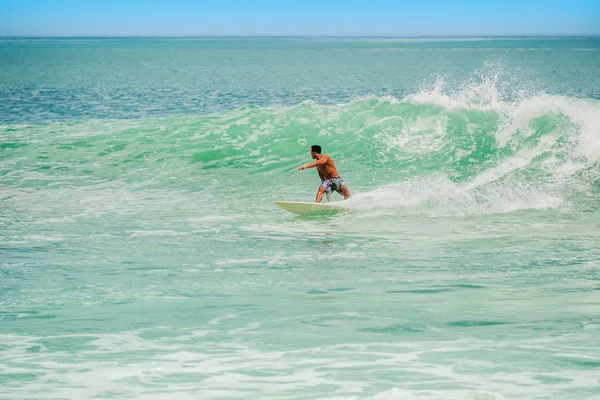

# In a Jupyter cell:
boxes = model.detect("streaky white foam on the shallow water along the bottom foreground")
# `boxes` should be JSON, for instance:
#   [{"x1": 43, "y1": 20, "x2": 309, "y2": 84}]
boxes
[{"x1": 0, "y1": 324, "x2": 597, "y2": 400}]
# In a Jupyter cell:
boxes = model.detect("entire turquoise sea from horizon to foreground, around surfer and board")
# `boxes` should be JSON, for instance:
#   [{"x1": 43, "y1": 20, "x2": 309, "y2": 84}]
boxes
[{"x1": 0, "y1": 38, "x2": 600, "y2": 400}]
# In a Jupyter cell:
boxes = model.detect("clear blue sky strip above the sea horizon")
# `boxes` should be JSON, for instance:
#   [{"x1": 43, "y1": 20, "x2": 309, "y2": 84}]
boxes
[{"x1": 0, "y1": 0, "x2": 600, "y2": 36}]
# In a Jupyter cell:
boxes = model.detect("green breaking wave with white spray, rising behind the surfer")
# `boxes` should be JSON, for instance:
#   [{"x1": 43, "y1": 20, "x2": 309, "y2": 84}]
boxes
[{"x1": 0, "y1": 75, "x2": 600, "y2": 211}]
